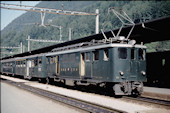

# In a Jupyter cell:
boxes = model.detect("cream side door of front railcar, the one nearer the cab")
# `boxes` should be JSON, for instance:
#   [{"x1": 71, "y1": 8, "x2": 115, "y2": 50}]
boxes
[{"x1": 80, "y1": 53, "x2": 85, "y2": 76}]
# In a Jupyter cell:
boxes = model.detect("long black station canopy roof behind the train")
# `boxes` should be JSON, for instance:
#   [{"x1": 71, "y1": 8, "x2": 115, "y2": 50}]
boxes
[{"x1": 3, "y1": 16, "x2": 170, "y2": 59}]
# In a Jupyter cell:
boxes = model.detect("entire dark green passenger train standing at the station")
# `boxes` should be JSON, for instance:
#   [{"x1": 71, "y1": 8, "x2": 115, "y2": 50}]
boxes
[{"x1": 0, "y1": 35, "x2": 147, "y2": 95}]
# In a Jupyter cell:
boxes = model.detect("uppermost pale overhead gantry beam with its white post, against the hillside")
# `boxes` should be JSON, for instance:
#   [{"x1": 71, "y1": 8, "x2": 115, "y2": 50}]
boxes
[{"x1": 0, "y1": 3, "x2": 99, "y2": 34}]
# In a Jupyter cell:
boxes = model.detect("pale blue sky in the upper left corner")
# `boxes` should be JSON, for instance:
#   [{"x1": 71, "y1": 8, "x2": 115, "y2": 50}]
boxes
[{"x1": 1, "y1": 1, "x2": 40, "y2": 30}]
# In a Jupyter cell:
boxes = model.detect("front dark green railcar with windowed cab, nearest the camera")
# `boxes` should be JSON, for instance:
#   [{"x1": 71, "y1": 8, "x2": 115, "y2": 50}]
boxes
[{"x1": 46, "y1": 43, "x2": 146, "y2": 95}]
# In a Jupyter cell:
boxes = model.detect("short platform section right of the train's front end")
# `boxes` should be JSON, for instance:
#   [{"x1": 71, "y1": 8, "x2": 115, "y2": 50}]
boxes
[{"x1": 142, "y1": 87, "x2": 170, "y2": 101}]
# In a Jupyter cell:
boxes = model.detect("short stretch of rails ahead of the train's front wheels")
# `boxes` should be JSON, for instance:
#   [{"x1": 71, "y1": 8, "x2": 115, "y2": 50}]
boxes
[{"x1": 123, "y1": 96, "x2": 170, "y2": 109}]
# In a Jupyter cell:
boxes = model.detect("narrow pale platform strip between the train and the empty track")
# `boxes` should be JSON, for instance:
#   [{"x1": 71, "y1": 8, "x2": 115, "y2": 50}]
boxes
[{"x1": 0, "y1": 75, "x2": 169, "y2": 113}]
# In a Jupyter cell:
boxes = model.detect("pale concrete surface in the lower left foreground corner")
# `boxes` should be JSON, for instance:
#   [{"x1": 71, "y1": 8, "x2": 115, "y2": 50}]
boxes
[{"x1": 1, "y1": 82, "x2": 81, "y2": 113}]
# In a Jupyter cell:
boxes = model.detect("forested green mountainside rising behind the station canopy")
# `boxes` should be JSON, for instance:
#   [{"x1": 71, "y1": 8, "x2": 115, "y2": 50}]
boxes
[{"x1": 1, "y1": 1, "x2": 170, "y2": 57}]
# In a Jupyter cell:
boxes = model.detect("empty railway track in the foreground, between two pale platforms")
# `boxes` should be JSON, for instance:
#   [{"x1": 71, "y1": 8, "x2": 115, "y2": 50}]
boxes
[{"x1": 1, "y1": 78, "x2": 126, "y2": 113}]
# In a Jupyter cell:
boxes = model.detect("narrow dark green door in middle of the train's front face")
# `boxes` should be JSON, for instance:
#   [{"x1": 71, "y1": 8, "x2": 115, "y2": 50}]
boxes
[{"x1": 130, "y1": 48, "x2": 138, "y2": 79}]
